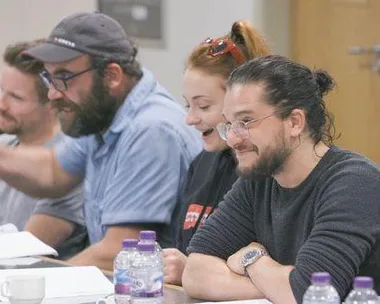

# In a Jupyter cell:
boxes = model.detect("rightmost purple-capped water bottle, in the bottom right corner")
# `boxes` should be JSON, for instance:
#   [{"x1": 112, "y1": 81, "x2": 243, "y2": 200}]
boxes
[{"x1": 344, "y1": 277, "x2": 380, "y2": 304}]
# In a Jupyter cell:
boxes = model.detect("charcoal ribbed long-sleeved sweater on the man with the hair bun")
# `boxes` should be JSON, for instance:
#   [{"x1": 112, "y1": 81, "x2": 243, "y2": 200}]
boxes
[{"x1": 188, "y1": 147, "x2": 380, "y2": 303}]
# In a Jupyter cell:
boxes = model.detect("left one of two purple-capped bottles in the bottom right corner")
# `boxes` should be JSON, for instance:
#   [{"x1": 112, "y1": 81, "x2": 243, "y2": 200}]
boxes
[{"x1": 302, "y1": 272, "x2": 340, "y2": 304}]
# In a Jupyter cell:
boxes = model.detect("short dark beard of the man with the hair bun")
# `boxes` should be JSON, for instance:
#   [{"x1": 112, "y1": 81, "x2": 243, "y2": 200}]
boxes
[{"x1": 237, "y1": 139, "x2": 291, "y2": 180}]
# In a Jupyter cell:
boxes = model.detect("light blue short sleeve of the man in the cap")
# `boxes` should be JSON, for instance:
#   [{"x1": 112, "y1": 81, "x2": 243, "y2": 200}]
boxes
[{"x1": 100, "y1": 122, "x2": 188, "y2": 225}]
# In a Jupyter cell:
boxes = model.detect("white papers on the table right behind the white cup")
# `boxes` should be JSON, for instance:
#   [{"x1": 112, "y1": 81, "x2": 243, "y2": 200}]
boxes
[{"x1": 0, "y1": 266, "x2": 113, "y2": 299}]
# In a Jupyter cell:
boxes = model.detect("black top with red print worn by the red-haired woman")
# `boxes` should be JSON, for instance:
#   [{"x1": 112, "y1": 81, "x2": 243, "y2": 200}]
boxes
[{"x1": 176, "y1": 149, "x2": 237, "y2": 253}]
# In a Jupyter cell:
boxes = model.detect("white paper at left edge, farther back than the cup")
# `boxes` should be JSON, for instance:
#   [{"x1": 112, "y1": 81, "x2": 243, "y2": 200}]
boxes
[{"x1": 0, "y1": 231, "x2": 58, "y2": 259}]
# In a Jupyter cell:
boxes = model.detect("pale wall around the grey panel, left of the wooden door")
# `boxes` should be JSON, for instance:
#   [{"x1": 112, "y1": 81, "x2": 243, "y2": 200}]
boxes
[{"x1": 0, "y1": 0, "x2": 289, "y2": 99}]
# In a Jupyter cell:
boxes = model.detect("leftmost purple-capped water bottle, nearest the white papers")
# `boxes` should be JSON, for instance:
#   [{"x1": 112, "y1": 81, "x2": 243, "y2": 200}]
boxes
[{"x1": 113, "y1": 239, "x2": 138, "y2": 304}]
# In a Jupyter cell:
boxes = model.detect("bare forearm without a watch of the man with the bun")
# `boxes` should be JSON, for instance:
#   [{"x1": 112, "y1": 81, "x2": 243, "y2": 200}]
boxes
[{"x1": 182, "y1": 253, "x2": 264, "y2": 301}]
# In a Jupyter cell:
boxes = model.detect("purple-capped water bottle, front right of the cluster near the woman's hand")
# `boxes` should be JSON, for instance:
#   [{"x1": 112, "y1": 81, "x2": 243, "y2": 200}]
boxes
[{"x1": 131, "y1": 242, "x2": 164, "y2": 304}]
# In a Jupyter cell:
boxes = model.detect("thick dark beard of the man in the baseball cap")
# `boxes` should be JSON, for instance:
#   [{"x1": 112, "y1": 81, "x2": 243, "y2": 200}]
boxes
[{"x1": 56, "y1": 75, "x2": 122, "y2": 137}]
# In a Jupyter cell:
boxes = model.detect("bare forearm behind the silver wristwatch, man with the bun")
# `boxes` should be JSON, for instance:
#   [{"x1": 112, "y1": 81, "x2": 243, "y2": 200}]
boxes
[{"x1": 247, "y1": 256, "x2": 296, "y2": 304}]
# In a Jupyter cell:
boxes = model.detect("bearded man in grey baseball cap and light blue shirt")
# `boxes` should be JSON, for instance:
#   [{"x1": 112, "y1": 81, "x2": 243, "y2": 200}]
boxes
[{"x1": 0, "y1": 13, "x2": 202, "y2": 269}]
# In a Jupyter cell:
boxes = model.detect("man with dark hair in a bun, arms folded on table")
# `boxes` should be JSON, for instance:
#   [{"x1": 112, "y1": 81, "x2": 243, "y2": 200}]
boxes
[{"x1": 182, "y1": 56, "x2": 380, "y2": 303}]
